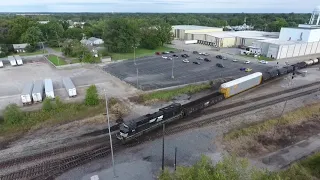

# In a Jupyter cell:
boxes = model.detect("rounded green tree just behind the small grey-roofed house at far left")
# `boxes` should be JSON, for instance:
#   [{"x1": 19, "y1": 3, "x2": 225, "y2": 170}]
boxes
[{"x1": 21, "y1": 26, "x2": 43, "y2": 46}]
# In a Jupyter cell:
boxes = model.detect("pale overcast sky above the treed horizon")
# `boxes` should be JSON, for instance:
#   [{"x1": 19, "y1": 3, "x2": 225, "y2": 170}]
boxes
[{"x1": 0, "y1": 0, "x2": 320, "y2": 13}]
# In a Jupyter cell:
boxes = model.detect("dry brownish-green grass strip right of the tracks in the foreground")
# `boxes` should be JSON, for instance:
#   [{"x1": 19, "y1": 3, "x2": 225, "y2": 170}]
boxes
[{"x1": 222, "y1": 103, "x2": 320, "y2": 157}]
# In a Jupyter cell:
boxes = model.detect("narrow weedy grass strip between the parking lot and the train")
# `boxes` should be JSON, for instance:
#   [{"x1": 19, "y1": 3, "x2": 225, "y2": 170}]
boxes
[{"x1": 138, "y1": 83, "x2": 211, "y2": 104}]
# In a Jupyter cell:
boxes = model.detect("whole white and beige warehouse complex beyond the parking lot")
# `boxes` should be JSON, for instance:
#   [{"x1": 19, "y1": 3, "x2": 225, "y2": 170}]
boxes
[{"x1": 173, "y1": 7, "x2": 320, "y2": 59}]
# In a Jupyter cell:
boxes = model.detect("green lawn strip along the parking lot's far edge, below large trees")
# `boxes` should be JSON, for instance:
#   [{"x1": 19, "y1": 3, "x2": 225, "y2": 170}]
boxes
[{"x1": 110, "y1": 47, "x2": 175, "y2": 60}]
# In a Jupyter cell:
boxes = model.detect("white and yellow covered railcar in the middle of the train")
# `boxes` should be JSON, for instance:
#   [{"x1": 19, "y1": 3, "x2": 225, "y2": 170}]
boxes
[{"x1": 220, "y1": 72, "x2": 262, "y2": 98}]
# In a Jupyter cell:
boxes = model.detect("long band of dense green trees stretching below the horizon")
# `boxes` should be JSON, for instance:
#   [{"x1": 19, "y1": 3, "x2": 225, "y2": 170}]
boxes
[{"x1": 0, "y1": 13, "x2": 310, "y2": 56}]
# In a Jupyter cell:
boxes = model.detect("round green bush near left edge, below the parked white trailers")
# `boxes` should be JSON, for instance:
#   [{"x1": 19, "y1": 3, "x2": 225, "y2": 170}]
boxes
[{"x1": 3, "y1": 104, "x2": 24, "y2": 124}]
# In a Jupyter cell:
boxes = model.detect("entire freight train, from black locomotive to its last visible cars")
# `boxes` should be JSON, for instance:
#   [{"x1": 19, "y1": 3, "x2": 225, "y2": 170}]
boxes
[{"x1": 117, "y1": 58, "x2": 320, "y2": 143}]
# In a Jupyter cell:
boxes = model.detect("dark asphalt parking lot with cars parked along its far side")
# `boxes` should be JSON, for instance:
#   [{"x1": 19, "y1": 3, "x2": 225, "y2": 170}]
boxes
[{"x1": 104, "y1": 52, "x2": 272, "y2": 90}]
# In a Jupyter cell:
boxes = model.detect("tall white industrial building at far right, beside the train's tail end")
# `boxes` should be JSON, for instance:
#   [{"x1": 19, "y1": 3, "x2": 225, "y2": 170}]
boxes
[{"x1": 253, "y1": 6, "x2": 320, "y2": 59}]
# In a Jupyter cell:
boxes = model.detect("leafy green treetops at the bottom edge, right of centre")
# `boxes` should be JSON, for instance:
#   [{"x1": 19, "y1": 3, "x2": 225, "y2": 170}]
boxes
[{"x1": 159, "y1": 156, "x2": 281, "y2": 180}]
